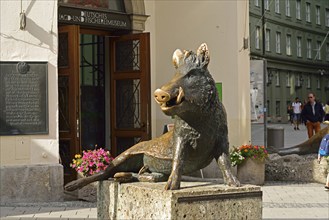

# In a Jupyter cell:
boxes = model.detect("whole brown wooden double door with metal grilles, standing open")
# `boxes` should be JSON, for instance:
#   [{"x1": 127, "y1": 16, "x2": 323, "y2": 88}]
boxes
[{"x1": 58, "y1": 25, "x2": 151, "y2": 182}]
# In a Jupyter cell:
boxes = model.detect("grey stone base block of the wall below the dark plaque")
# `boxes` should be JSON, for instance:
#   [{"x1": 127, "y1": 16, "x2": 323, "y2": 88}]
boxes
[{"x1": 0, "y1": 164, "x2": 64, "y2": 203}]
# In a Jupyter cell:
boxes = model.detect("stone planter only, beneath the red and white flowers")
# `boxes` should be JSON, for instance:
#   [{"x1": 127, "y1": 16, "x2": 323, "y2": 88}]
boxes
[{"x1": 237, "y1": 158, "x2": 265, "y2": 185}]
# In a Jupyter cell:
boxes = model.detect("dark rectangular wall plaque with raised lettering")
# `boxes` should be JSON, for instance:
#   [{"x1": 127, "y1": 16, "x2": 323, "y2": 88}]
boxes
[{"x1": 0, "y1": 62, "x2": 48, "y2": 135}]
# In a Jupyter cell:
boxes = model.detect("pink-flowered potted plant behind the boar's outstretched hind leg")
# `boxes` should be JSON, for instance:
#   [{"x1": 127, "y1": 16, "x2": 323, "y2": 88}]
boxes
[{"x1": 70, "y1": 145, "x2": 113, "y2": 202}]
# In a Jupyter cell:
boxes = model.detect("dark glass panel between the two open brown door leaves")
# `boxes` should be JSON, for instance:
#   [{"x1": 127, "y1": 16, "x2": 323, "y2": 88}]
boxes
[{"x1": 80, "y1": 34, "x2": 106, "y2": 150}]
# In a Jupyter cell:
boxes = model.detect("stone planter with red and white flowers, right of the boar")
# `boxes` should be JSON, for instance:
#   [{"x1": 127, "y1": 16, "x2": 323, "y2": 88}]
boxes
[{"x1": 230, "y1": 144, "x2": 268, "y2": 185}]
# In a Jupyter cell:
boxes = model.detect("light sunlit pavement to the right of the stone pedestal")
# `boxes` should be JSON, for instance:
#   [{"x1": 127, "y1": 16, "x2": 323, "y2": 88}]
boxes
[{"x1": 262, "y1": 182, "x2": 329, "y2": 219}]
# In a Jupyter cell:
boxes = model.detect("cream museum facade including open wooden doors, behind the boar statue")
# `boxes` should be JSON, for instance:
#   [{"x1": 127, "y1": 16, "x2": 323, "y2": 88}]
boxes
[{"x1": 0, "y1": 0, "x2": 250, "y2": 202}]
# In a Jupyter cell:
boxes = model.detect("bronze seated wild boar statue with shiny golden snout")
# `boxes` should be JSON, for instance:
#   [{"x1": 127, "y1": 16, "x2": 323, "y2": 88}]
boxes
[{"x1": 65, "y1": 44, "x2": 240, "y2": 191}]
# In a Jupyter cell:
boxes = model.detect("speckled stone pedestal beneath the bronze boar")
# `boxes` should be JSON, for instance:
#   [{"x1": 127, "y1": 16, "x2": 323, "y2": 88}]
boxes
[{"x1": 97, "y1": 181, "x2": 262, "y2": 219}]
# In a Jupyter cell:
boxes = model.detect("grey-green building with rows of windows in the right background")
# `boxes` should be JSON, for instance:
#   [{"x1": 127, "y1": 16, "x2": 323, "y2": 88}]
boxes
[{"x1": 249, "y1": 0, "x2": 329, "y2": 122}]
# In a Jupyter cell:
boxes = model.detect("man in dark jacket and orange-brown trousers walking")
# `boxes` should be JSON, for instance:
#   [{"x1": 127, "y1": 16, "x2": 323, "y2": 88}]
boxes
[{"x1": 301, "y1": 92, "x2": 324, "y2": 138}]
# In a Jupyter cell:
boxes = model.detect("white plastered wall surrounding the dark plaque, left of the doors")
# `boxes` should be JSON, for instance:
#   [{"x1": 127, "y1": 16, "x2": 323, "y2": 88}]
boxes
[{"x1": 0, "y1": 0, "x2": 59, "y2": 165}]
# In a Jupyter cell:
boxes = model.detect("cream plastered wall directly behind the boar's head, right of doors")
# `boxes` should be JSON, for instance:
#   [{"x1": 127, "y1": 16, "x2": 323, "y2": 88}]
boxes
[{"x1": 145, "y1": 0, "x2": 251, "y2": 146}]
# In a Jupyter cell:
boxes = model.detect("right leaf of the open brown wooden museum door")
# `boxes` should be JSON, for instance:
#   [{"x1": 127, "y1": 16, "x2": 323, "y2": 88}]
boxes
[{"x1": 110, "y1": 33, "x2": 151, "y2": 156}]
